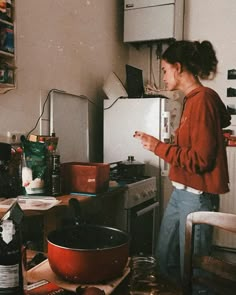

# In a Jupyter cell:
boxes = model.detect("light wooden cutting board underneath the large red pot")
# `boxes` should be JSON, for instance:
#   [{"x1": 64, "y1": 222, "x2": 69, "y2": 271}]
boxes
[{"x1": 27, "y1": 259, "x2": 130, "y2": 295}]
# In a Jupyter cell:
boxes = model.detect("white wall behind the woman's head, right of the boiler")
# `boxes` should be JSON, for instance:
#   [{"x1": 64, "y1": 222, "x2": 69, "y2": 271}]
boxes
[{"x1": 185, "y1": 0, "x2": 236, "y2": 134}]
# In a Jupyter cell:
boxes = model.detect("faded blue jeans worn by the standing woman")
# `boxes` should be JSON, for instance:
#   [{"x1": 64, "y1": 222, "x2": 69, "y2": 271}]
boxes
[{"x1": 155, "y1": 189, "x2": 218, "y2": 294}]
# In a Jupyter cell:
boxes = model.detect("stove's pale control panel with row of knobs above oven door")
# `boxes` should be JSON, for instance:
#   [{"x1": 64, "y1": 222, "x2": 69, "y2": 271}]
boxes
[{"x1": 125, "y1": 177, "x2": 157, "y2": 209}]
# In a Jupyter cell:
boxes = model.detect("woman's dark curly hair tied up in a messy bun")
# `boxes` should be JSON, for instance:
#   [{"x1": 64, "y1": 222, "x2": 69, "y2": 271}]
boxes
[{"x1": 162, "y1": 40, "x2": 218, "y2": 79}]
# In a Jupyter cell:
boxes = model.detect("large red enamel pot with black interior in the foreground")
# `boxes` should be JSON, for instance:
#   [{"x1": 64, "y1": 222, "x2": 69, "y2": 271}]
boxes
[{"x1": 48, "y1": 215, "x2": 129, "y2": 283}]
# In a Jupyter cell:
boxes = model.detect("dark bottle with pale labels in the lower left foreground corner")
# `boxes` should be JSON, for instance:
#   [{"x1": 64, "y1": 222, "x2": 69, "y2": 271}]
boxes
[{"x1": 0, "y1": 202, "x2": 24, "y2": 295}]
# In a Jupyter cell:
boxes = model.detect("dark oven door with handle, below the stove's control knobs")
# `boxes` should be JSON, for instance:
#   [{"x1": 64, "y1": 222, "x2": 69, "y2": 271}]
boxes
[{"x1": 127, "y1": 198, "x2": 159, "y2": 255}]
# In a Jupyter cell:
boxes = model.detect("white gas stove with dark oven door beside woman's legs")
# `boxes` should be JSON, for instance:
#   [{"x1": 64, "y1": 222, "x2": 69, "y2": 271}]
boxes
[{"x1": 116, "y1": 176, "x2": 159, "y2": 256}]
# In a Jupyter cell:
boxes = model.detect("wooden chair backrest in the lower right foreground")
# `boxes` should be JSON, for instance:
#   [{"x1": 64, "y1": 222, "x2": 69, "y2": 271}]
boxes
[{"x1": 183, "y1": 211, "x2": 236, "y2": 295}]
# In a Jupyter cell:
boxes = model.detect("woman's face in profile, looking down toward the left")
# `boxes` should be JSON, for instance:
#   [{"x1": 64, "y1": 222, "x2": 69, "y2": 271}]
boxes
[{"x1": 161, "y1": 60, "x2": 179, "y2": 90}]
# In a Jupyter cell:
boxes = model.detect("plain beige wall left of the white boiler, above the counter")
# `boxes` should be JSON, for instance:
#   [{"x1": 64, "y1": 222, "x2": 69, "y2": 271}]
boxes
[{"x1": 0, "y1": 0, "x2": 128, "y2": 160}]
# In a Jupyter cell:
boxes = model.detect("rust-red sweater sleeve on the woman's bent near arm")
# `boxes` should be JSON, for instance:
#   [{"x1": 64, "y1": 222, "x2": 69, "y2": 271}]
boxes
[{"x1": 155, "y1": 93, "x2": 221, "y2": 174}]
